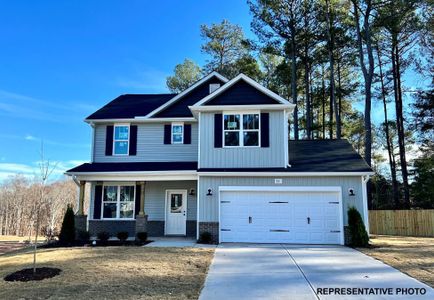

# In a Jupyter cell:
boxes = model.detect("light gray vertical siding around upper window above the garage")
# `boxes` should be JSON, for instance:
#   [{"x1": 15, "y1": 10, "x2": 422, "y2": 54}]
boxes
[{"x1": 199, "y1": 111, "x2": 285, "y2": 168}]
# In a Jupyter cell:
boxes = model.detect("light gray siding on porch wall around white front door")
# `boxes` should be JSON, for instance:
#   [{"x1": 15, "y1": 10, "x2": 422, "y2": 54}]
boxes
[{"x1": 89, "y1": 180, "x2": 197, "y2": 221}]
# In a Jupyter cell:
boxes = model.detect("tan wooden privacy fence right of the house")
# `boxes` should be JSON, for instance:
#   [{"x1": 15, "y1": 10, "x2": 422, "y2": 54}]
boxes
[{"x1": 369, "y1": 209, "x2": 434, "y2": 237}]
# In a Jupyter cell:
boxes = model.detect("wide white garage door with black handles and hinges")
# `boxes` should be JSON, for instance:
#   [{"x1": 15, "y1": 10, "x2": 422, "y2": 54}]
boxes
[{"x1": 220, "y1": 187, "x2": 343, "y2": 244}]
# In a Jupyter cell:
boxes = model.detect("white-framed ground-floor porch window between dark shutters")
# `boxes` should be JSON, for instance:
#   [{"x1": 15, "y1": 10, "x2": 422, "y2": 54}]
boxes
[{"x1": 101, "y1": 184, "x2": 136, "y2": 219}]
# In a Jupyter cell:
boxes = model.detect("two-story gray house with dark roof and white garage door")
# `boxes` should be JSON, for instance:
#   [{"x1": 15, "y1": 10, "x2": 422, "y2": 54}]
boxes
[{"x1": 67, "y1": 72, "x2": 372, "y2": 244}]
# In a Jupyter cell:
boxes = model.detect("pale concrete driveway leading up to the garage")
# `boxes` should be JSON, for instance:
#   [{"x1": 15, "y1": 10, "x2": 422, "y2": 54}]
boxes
[{"x1": 199, "y1": 244, "x2": 434, "y2": 300}]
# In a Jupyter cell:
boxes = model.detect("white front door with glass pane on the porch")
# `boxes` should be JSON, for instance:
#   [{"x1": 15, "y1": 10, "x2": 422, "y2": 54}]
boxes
[{"x1": 165, "y1": 190, "x2": 187, "y2": 235}]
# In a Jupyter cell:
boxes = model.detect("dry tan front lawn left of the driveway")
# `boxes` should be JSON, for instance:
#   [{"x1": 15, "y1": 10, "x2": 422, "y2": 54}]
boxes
[{"x1": 0, "y1": 247, "x2": 214, "y2": 299}]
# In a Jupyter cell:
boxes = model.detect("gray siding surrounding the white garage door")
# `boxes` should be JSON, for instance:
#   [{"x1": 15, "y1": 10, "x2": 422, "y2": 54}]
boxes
[{"x1": 199, "y1": 176, "x2": 364, "y2": 225}]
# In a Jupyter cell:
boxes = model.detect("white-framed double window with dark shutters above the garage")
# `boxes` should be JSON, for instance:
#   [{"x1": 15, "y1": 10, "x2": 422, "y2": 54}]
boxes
[{"x1": 223, "y1": 112, "x2": 261, "y2": 147}]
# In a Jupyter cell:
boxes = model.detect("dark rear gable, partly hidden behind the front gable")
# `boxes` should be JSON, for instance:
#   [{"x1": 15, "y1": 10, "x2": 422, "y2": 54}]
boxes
[{"x1": 152, "y1": 75, "x2": 226, "y2": 118}]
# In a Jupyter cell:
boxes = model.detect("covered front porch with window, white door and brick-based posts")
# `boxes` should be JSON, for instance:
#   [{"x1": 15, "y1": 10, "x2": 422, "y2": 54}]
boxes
[{"x1": 76, "y1": 179, "x2": 197, "y2": 239}]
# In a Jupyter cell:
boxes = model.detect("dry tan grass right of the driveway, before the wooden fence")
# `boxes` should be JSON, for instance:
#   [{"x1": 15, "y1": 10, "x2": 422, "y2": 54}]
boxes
[{"x1": 358, "y1": 235, "x2": 434, "y2": 287}]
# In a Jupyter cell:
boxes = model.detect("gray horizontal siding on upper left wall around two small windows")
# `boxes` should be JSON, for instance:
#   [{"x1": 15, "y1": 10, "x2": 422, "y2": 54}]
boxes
[{"x1": 93, "y1": 123, "x2": 198, "y2": 162}]
